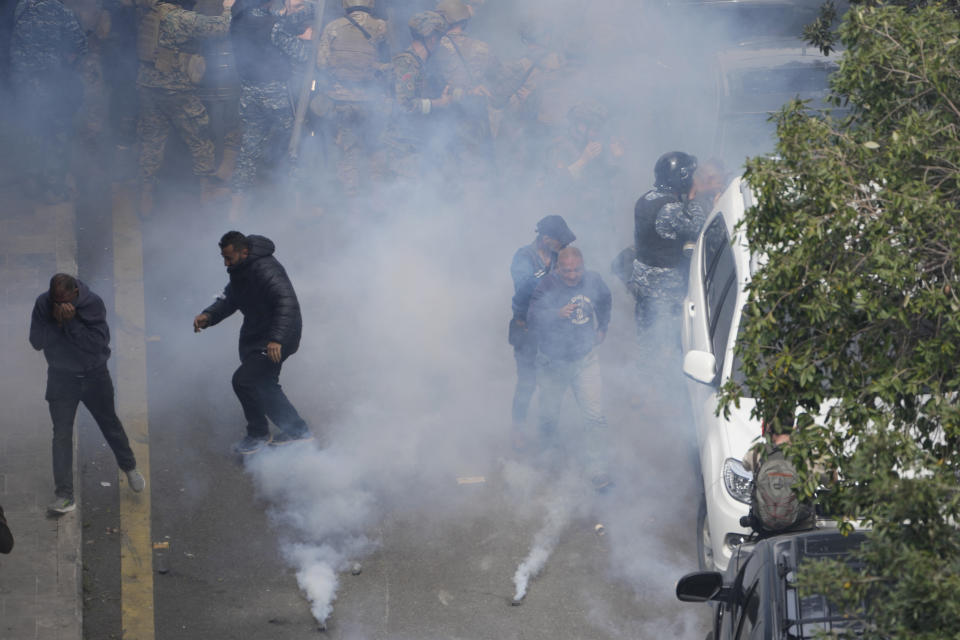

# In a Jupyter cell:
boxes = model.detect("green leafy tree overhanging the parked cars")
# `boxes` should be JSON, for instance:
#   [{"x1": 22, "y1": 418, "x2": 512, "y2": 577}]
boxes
[{"x1": 722, "y1": 3, "x2": 960, "y2": 640}]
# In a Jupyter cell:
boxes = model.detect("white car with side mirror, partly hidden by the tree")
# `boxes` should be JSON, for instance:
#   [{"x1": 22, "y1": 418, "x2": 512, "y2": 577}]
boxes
[{"x1": 682, "y1": 178, "x2": 760, "y2": 571}]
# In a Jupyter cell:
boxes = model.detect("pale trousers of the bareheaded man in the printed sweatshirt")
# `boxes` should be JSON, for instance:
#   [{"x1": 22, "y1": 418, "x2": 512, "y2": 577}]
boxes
[{"x1": 537, "y1": 349, "x2": 607, "y2": 476}]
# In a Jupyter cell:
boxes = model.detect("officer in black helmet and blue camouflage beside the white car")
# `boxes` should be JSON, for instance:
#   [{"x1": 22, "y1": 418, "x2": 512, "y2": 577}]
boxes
[{"x1": 627, "y1": 151, "x2": 706, "y2": 338}]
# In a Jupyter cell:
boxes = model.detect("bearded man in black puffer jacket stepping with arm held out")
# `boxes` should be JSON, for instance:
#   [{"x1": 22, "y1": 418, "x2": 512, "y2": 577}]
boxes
[{"x1": 193, "y1": 231, "x2": 313, "y2": 455}]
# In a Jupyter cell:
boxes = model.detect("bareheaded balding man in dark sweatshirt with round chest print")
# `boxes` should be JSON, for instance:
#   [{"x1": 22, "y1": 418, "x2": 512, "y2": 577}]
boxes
[{"x1": 527, "y1": 247, "x2": 612, "y2": 490}]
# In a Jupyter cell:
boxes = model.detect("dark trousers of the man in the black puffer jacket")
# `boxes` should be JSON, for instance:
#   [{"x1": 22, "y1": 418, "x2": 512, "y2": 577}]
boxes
[{"x1": 233, "y1": 353, "x2": 307, "y2": 438}]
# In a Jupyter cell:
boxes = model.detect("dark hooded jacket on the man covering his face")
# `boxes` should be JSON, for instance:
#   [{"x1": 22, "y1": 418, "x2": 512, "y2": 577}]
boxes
[{"x1": 30, "y1": 280, "x2": 110, "y2": 373}]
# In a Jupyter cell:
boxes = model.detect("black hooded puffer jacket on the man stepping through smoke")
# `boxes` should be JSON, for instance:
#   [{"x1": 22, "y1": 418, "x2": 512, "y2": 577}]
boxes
[{"x1": 203, "y1": 236, "x2": 303, "y2": 360}]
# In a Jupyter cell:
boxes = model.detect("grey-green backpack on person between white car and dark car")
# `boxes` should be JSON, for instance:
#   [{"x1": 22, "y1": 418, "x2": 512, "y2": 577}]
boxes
[{"x1": 750, "y1": 445, "x2": 805, "y2": 532}]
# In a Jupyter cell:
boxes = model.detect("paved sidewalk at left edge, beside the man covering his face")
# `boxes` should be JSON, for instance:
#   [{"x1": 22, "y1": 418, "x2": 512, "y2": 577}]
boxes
[{"x1": 0, "y1": 184, "x2": 83, "y2": 640}]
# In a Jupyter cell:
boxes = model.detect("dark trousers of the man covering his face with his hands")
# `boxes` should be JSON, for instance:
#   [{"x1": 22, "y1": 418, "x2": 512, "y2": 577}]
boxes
[{"x1": 46, "y1": 366, "x2": 137, "y2": 498}]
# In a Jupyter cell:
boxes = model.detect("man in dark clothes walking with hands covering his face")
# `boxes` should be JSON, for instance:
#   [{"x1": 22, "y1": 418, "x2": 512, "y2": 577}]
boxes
[{"x1": 30, "y1": 273, "x2": 146, "y2": 514}]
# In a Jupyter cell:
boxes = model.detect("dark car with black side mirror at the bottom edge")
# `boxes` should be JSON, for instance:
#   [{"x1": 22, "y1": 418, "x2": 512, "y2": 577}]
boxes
[{"x1": 677, "y1": 529, "x2": 865, "y2": 640}]
